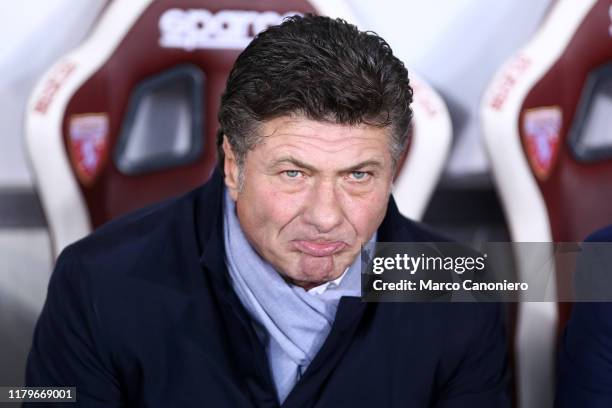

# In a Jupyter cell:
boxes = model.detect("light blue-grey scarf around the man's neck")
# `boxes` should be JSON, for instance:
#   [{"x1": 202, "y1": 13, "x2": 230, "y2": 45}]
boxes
[{"x1": 223, "y1": 190, "x2": 376, "y2": 403}]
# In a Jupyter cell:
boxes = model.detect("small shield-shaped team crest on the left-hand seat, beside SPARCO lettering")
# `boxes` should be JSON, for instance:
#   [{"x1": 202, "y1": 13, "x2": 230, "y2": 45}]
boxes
[{"x1": 68, "y1": 113, "x2": 108, "y2": 186}]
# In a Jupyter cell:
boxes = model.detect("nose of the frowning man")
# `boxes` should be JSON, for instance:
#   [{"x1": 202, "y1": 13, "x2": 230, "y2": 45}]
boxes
[{"x1": 304, "y1": 180, "x2": 344, "y2": 234}]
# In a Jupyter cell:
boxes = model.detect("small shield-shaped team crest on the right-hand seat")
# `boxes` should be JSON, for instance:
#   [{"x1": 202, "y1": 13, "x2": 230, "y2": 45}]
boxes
[{"x1": 522, "y1": 106, "x2": 563, "y2": 181}]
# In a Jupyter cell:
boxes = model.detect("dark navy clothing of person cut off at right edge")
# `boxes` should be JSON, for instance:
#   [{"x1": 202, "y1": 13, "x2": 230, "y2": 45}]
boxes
[{"x1": 555, "y1": 226, "x2": 612, "y2": 408}]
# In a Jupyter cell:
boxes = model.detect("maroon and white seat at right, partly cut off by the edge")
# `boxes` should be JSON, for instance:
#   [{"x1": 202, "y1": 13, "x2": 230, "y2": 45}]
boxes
[{"x1": 481, "y1": 0, "x2": 612, "y2": 408}]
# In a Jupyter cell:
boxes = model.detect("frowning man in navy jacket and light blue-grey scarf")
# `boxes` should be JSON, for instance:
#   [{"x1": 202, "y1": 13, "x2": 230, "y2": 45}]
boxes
[{"x1": 27, "y1": 16, "x2": 508, "y2": 407}]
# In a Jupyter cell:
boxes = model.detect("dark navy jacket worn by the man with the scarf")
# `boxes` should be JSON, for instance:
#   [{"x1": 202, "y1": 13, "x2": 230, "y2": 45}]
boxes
[{"x1": 27, "y1": 168, "x2": 509, "y2": 408}]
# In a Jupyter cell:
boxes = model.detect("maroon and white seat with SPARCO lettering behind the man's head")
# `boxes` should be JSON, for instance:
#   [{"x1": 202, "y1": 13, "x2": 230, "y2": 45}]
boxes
[{"x1": 25, "y1": 0, "x2": 451, "y2": 262}]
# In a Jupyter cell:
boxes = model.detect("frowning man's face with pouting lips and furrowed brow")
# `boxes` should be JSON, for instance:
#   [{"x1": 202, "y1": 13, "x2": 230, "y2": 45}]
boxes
[{"x1": 223, "y1": 116, "x2": 393, "y2": 289}]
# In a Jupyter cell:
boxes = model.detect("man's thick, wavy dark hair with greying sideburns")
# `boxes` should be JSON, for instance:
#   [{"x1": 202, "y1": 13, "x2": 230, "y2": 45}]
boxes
[{"x1": 217, "y1": 15, "x2": 412, "y2": 173}]
